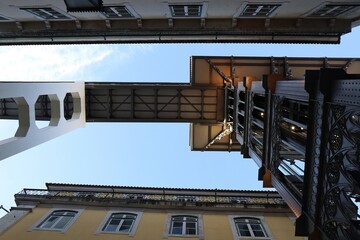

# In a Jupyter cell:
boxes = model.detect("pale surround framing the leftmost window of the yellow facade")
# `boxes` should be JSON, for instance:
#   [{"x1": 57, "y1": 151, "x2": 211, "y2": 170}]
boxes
[{"x1": 28, "y1": 208, "x2": 84, "y2": 232}]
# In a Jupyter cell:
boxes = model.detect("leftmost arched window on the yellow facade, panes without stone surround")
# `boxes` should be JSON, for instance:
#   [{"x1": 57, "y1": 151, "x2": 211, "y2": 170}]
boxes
[{"x1": 36, "y1": 210, "x2": 78, "y2": 230}]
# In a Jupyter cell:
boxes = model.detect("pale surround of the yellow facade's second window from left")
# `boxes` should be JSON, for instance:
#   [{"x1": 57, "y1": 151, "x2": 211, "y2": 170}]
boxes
[{"x1": 95, "y1": 209, "x2": 143, "y2": 236}]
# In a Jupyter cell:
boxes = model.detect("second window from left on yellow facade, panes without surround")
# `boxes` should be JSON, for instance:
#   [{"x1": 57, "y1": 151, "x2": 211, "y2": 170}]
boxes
[{"x1": 102, "y1": 213, "x2": 137, "y2": 233}]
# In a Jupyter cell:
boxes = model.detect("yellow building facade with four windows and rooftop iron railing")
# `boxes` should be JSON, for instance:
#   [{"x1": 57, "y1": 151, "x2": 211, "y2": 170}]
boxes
[{"x1": 0, "y1": 184, "x2": 303, "y2": 240}]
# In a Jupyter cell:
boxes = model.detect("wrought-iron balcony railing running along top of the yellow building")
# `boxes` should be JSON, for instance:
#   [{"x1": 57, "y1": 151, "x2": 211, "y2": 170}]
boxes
[{"x1": 15, "y1": 189, "x2": 286, "y2": 207}]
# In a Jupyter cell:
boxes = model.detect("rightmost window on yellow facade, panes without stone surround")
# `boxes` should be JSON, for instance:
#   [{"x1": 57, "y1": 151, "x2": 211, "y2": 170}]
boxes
[{"x1": 234, "y1": 217, "x2": 268, "y2": 238}]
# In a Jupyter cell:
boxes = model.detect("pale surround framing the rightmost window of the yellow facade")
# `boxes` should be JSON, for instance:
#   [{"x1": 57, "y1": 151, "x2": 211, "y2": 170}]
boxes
[{"x1": 229, "y1": 215, "x2": 275, "y2": 240}]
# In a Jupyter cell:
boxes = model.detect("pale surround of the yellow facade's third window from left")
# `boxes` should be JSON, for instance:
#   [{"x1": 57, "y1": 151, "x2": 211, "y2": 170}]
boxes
[{"x1": 163, "y1": 212, "x2": 204, "y2": 239}]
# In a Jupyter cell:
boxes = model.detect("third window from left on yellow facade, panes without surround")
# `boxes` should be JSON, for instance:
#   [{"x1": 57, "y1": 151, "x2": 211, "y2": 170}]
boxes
[{"x1": 169, "y1": 216, "x2": 198, "y2": 235}]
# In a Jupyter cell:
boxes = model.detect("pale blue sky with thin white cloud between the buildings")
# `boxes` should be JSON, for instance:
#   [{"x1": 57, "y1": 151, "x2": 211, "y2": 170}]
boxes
[{"x1": 0, "y1": 27, "x2": 360, "y2": 216}]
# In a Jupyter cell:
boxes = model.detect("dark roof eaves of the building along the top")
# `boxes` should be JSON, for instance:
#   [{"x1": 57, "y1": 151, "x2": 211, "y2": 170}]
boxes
[{"x1": 0, "y1": 19, "x2": 352, "y2": 45}]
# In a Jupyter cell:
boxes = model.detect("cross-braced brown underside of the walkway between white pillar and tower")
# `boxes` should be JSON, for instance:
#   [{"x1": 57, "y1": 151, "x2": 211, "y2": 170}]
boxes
[{"x1": 86, "y1": 82, "x2": 219, "y2": 123}]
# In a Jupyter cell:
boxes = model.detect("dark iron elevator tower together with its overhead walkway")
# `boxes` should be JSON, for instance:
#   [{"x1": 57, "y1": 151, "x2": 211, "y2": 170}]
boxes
[{"x1": 0, "y1": 56, "x2": 360, "y2": 239}]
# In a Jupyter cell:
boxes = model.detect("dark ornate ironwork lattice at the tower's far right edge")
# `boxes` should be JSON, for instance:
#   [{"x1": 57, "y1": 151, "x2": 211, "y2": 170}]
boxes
[{"x1": 322, "y1": 103, "x2": 360, "y2": 239}]
